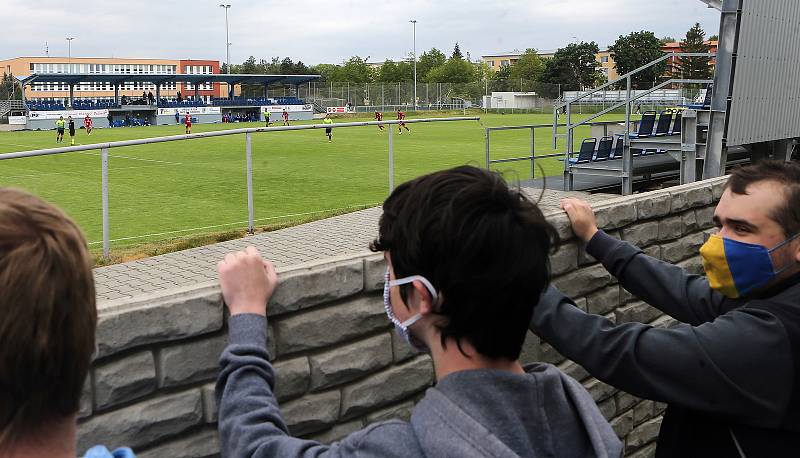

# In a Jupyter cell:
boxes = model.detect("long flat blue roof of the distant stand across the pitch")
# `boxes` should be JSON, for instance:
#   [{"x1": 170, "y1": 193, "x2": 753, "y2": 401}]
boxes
[{"x1": 19, "y1": 73, "x2": 320, "y2": 85}]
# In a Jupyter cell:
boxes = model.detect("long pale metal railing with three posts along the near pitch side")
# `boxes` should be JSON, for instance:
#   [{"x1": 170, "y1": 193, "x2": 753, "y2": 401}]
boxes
[{"x1": 0, "y1": 117, "x2": 480, "y2": 258}]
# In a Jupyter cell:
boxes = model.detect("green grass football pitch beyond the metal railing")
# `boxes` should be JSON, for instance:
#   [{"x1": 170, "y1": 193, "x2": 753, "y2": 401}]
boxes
[{"x1": 0, "y1": 113, "x2": 620, "y2": 252}]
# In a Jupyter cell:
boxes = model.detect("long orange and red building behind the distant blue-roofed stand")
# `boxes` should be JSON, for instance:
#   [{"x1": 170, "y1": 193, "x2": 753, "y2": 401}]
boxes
[{"x1": 0, "y1": 57, "x2": 227, "y2": 101}]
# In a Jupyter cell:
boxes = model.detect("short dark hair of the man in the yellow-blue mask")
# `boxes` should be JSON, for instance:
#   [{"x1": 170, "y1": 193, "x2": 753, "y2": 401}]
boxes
[{"x1": 726, "y1": 160, "x2": 800, "y2": 237}]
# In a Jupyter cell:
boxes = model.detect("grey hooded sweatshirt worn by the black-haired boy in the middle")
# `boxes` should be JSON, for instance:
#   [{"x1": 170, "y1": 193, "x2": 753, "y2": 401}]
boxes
[{"x1": 216, "y1": 314, "x2": 622, "y2": 458}]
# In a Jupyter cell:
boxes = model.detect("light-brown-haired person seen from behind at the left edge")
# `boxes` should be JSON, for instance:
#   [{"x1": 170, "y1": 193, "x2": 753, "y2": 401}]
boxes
[{"x1": 0, "y1": 188, "x2": 132, "y2": 458}]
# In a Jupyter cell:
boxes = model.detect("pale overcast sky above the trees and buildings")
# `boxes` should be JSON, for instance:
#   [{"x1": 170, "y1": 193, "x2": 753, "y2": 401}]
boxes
[{"x1": 0, "y1": 0, "x2": 719, "y2": 64}]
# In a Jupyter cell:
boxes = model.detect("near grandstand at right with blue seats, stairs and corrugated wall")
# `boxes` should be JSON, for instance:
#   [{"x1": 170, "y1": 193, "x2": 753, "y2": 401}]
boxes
[{"x1": 550, "y1": 0, "x2": 800, "y2": 194}]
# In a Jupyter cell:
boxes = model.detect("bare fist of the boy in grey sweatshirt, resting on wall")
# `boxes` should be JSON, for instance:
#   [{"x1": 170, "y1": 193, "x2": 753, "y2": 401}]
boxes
[{"x1": 217, "y1": 246, "x2": 278, "y2": 316}]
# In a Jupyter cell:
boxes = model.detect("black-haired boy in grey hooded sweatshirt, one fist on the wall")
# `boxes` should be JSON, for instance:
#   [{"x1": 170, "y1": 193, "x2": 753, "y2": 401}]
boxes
[{"x1": 216, "y1": 167, "x2": 622, "y2": 458}]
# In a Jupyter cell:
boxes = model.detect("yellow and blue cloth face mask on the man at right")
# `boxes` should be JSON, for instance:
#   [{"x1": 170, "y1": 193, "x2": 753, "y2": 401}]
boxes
[{"x1": 700, "y1": 234, "x2": 800, "y2": 299}]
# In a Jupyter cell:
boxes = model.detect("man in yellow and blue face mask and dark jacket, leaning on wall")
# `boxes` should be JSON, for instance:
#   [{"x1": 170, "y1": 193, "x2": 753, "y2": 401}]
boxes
[{"x1": 531, "y1": 161, "x2": 800, "y2": 457}]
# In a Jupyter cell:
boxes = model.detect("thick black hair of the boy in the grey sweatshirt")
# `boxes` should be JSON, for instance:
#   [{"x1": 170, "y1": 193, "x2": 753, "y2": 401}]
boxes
[{"x1": 370, "y1": 166, "x2": 558, "y2": 360}]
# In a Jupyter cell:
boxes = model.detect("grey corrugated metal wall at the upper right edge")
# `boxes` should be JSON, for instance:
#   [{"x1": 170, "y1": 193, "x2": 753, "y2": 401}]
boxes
[{"x1": 727, "y1": 0, "x2": 800, "y2": 146}]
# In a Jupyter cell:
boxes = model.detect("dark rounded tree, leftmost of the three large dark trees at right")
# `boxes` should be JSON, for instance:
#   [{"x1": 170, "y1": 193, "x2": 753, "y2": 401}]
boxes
[{"x1": 540, "y1": 41, "x2": 600, "y2": 91}]
